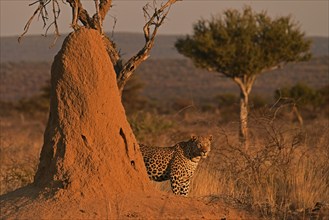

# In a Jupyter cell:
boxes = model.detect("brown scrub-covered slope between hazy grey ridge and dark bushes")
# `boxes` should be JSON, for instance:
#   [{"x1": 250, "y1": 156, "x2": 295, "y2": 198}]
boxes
[{"x1": 0, "y1": 56, "x2": 329, "y2": 103}]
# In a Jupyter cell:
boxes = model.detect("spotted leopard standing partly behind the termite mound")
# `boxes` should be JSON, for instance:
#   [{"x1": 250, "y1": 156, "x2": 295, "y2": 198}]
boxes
[{"x1": 139, "y1": 135, "x2": 213, "y2": 196}]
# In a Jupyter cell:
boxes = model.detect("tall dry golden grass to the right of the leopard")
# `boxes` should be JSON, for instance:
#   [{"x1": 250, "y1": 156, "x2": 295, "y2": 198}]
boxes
[{"x1": 187, "y1": 113, "x2": 329, "y2": 219}]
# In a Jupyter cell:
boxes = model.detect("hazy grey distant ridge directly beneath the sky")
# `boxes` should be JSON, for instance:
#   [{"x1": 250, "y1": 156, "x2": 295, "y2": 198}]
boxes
[{"x1": 0, "y1": 33, "x2": 329, "y2": 62}]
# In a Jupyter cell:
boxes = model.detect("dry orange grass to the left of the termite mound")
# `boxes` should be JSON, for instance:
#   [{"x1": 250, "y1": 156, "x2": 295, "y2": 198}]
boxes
[{"x1": 0, "y1": 115, "x2": 45, "y2": 195}]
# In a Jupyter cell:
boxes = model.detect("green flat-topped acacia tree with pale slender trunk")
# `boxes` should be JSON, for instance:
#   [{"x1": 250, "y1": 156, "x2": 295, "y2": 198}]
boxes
[{"x1": 175, "y1": 7, "x2": 311, "y2": 148}]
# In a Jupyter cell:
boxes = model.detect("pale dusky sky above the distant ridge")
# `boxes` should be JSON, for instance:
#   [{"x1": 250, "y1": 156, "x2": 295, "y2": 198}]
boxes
[{"x1": 0, "y1": 0, "x2": 329, "y2": 37}]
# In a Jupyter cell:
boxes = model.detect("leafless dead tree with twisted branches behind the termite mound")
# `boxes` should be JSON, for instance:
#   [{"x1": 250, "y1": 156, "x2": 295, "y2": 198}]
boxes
[{"x1": 18, "y1": 0, "x2": 180, "y2": 94}]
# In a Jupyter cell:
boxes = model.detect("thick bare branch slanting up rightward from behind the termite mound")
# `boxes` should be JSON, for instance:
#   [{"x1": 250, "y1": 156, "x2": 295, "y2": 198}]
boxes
[{"x1": 117, "y1": 0, "x2": 178, "y2": 93}]
